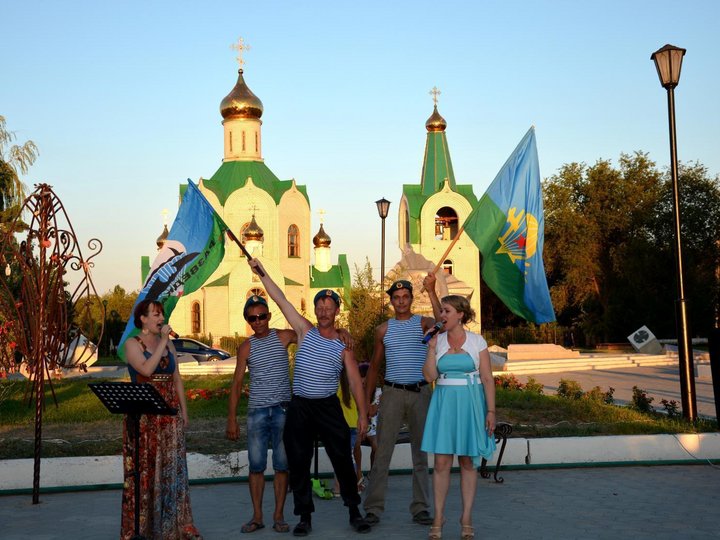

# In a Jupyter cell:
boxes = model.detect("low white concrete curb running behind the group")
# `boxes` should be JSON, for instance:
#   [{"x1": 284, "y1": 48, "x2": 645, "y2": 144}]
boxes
[{"x1": 0, "y1": 433, "x2": 720, "y2": 495}]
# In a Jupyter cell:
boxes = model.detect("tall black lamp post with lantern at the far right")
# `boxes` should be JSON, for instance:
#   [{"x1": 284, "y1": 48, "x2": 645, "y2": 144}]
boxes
[{"x1": 650, "y1": 45, "x2": 697, "y2": 421}]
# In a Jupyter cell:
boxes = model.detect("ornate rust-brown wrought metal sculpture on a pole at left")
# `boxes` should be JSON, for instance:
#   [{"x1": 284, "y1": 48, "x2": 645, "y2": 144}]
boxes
[{"x1": 0, "y1": 184, "x2": 105, "y2": 504}]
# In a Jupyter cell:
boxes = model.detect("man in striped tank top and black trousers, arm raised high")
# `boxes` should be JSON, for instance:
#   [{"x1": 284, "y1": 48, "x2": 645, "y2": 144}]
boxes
[{"x1": 248, "y1": 259, "x2": 370, "y2": 536}]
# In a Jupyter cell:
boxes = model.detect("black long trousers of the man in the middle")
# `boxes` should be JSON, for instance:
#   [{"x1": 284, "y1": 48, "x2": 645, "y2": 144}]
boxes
[{"x1": 283, "y1": 396, "x2": 360, "y2": 516}]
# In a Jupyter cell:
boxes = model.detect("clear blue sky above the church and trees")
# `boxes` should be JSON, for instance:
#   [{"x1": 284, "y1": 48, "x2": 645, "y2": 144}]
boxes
[{"x1": 0, "y1": 0, "x2": 720, "y2": 292}]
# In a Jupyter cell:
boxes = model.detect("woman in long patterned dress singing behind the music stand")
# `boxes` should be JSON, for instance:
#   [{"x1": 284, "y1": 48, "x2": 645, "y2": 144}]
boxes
[{"x1": 120, "y1": 300, "x2": 202, "y2": 540}]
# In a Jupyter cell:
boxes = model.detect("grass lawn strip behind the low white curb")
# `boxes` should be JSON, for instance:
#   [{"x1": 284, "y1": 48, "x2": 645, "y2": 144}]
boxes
[{"x1": 0, "y1": 375, "x2": 716, "y2": 459}]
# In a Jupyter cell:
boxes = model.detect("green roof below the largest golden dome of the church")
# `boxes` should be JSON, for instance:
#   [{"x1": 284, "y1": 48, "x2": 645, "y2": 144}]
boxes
[{"x1": 203, "y1": 161, "x2": 310, "y2": 206}]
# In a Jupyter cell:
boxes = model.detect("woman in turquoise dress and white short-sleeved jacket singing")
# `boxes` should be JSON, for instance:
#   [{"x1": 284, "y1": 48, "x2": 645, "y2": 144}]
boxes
[{"x1": 421, "y1": 295, "x2": 495, "y2": 540}]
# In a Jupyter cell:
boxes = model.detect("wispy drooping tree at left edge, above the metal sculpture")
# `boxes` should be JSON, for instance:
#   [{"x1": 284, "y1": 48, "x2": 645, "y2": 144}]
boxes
[{"x1": 0, "y1": 115, "x2": 38, "y2": 227}]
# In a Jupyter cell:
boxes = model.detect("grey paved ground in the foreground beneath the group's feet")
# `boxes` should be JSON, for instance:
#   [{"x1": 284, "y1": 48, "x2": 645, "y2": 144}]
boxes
[{"x1": 0, "y1": 465, "x2": 720, "y2": 540}]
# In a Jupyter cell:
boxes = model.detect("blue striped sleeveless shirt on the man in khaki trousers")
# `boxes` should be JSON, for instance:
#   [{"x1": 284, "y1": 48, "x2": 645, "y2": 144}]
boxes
[{"x1": 383, "y1": 315, "x2": 427, "y2": 384}]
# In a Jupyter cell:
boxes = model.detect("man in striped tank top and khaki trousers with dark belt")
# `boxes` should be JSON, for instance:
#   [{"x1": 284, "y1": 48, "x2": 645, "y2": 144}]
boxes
[{"x1": 364, "y1": 273, "x2": 440, "y2": 525}]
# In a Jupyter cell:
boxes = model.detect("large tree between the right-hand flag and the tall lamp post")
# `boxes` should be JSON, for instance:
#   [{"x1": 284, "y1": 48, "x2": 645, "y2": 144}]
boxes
[{"x1": 544, "y1": 152, "x2": 662, "y2": 343}]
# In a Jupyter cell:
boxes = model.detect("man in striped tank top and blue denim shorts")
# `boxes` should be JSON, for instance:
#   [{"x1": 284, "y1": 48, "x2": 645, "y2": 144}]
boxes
[{"x1": 225, "y1": 295, "x2": 297, "y2": 533}]
